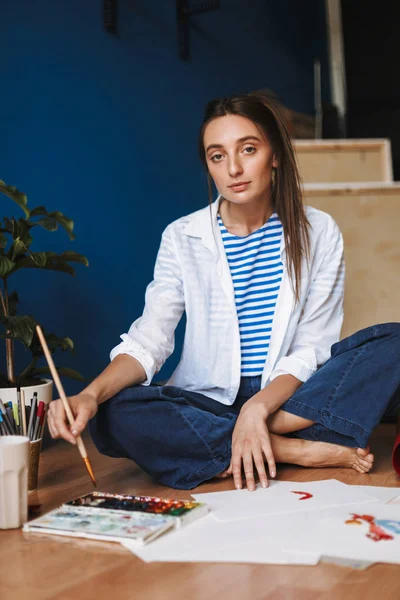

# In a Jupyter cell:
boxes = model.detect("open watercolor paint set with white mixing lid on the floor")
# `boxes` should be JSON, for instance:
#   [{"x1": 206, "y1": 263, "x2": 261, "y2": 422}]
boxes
[{"x1": 23, "y1": 492, "x2": 208, "y2": 545}]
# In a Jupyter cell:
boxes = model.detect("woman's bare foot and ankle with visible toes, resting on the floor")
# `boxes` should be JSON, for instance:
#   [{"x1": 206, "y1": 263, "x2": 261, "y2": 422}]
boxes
[{"x1": 271, "y1": 434, "x2": 374, "y2": 473}]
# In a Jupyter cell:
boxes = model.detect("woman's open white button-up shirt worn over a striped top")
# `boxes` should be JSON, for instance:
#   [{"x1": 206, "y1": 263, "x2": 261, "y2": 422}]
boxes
[{"x1": 110, "y1": 197, "x2": 344, "y2": 405}]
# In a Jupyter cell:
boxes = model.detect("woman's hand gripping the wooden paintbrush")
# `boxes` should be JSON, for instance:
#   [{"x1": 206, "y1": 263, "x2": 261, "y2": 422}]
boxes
[{"x1": 48, "y1": 391, "x2": 98, "y2": 444}]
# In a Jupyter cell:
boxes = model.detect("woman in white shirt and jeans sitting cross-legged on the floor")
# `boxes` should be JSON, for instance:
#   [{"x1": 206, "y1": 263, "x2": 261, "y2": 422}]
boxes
[{"x1": 49, "y1": 93, "x2": 400, "y2": 490}]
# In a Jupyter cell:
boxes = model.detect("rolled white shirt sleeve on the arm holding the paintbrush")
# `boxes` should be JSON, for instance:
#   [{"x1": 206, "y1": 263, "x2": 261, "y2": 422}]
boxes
[{"x1": 110, "y1": 225, "x2": 185, "y2": 385}]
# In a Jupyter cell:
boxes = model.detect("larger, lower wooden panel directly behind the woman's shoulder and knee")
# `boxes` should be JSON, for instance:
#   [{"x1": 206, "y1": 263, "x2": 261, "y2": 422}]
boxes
[{"x1": 305, "y1": 185, "x2": 400, "y2": 337}]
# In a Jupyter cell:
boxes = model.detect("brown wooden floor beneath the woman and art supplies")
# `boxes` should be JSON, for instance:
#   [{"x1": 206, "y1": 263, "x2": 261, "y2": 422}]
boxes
[{"x1": 0, "y1": 424, "x2": 400, "y2": 600}]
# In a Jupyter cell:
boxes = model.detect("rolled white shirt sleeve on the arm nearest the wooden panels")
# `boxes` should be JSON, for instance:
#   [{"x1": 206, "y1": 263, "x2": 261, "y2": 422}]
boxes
[{"x1": 270, "y1": 218, "x2": 345, "y2": 382}]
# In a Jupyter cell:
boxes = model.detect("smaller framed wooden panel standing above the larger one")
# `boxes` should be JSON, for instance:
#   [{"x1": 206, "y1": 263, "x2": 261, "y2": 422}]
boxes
[{"x1": 293, "y1": 139, "x2": 393, "y2": 183}]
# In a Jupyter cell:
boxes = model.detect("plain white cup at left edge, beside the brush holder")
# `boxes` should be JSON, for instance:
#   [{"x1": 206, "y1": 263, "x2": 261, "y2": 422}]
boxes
[{"x1": 0, "y1": 435, "x2": 29, "y2": 529}]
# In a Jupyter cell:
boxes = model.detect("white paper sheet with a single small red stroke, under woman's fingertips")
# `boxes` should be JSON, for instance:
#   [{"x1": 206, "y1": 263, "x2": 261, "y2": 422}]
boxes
[{"x1": 192, "y1": 479, "x2": 379, "y2": 522}]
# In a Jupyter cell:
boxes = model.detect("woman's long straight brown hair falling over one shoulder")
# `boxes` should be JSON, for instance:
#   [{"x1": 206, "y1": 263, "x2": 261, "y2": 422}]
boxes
[{"x1": 198, "y1": 92, "x2": 310, "y2": 301}]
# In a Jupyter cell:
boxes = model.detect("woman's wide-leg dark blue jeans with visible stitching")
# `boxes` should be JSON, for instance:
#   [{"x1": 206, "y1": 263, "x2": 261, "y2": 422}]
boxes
[{"x1": 90, "y1": 323, "x2": 400, "y2": 489}]
